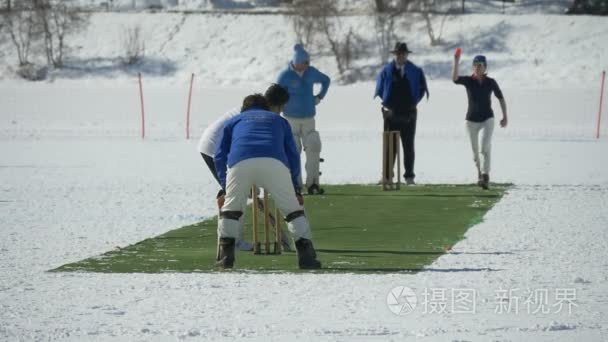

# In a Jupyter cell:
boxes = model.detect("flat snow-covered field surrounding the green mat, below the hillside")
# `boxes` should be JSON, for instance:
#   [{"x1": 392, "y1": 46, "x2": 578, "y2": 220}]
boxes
[{"x1": 0, "y1": 82, "x2": 608, "y2": 341}]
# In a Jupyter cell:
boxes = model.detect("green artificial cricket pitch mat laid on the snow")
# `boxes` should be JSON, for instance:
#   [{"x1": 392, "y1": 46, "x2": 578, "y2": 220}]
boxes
[{"x1": 52, "y1": 185, "x2": 509, "y2": 273}]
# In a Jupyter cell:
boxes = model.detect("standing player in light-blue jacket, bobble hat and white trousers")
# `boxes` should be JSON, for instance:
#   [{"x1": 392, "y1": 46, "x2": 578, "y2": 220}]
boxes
[{"x1": 277, "y1": 44, "x2": 330, "y2": 195}]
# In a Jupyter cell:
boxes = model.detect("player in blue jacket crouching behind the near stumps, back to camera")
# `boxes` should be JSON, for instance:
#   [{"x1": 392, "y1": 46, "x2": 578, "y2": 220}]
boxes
[{"x1": 214, "y1": 85, "x2": 321, "y2": 269}]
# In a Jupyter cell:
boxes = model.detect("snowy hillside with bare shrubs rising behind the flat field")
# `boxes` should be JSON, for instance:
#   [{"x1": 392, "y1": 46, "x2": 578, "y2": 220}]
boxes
[{"x1": 0, "y1": 6, "x2": 608, "y2": 87}]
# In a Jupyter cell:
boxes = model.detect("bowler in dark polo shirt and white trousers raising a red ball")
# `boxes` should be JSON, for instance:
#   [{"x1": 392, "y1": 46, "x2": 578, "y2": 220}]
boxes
[{"x1": 452, "y1": 52, "x2": 508, "y2": 189}]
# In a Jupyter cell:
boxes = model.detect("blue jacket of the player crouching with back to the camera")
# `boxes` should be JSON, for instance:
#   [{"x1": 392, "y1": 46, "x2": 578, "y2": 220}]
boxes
[{"x1": 213, "y1": 108, "x2": 301, "y2": 190}]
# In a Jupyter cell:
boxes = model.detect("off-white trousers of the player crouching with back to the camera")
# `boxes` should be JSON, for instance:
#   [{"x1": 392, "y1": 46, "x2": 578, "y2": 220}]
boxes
[{"x1": 217, "y1": 158, "x2": 312, "y2": 240}]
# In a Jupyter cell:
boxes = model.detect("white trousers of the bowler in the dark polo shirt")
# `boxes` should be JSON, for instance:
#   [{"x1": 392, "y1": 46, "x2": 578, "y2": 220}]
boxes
[{"x1": 465, "y1": 118, "x2": 494, "y2": 174}]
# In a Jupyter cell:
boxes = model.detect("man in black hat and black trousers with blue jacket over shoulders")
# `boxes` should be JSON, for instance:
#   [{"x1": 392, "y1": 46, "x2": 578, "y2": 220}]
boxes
[{"x1": 374, "y1": 42, "x2": 429, "y2": 185}]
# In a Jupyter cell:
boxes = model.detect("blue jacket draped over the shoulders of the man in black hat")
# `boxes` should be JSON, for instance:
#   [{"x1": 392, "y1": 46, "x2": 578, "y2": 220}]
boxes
[{"x1": 374, "y1": 60, "x2": 429, "y2": 106}]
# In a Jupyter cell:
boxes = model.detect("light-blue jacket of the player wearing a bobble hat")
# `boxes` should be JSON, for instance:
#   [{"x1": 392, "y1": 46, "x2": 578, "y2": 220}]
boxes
[{"x1": 277, "y1": 63, "x2": 331, "y2": 119}]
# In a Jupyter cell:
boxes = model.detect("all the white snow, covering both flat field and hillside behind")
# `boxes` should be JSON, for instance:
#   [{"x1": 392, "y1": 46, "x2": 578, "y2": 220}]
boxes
[{"x1": 0, "y1": 4, "x2": 608, "y2": 341}]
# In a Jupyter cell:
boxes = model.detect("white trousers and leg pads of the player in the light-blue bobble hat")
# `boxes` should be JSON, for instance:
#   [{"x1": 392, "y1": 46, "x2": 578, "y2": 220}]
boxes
[{"x1": 283, "y1": 115, "x2": 321, "y2": 187}]
